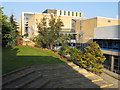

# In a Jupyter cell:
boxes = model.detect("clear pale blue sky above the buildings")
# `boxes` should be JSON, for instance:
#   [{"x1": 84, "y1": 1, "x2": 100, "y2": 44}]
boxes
[{"x1": 2, "y1": 2, "x2": 118, "y2": 20}]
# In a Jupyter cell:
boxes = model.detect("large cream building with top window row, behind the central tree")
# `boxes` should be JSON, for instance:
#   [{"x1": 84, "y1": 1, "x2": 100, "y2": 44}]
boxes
[{"x1": 19, "y1": 9, "x2": 84, "y2": 43}]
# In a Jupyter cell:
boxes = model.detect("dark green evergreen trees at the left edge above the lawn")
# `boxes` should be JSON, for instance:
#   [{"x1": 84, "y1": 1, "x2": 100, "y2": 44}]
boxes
[{"x1": 0, "y1": 7, "x2": 18, "y2": 47}]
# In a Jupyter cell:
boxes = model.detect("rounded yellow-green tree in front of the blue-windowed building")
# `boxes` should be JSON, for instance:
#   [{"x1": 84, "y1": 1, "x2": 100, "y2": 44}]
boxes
[{"x1": 80, "y1": 42, "x2": 106, "y2": 73}]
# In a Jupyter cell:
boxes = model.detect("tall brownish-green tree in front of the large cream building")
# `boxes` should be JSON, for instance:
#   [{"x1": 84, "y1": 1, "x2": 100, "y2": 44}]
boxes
[{"x1": 33, "y1": 15, "x2": 63, "y2": 50}]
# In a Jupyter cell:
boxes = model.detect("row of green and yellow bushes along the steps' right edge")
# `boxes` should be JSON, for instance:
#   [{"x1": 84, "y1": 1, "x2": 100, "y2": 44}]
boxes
[{"x1": 59, "y1": 42, "x2": 106, "y2": 74}]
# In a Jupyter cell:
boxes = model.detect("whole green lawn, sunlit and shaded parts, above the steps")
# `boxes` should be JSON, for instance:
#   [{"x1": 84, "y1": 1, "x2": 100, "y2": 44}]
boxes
[{"x1": 2, "y1": 46, "x2": 66, "y2": 74}]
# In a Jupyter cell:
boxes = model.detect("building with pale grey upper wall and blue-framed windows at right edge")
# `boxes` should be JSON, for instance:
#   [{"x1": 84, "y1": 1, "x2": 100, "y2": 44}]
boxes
[{"x1": 93, "y1": 25, "x2": 120, "y2": 74}]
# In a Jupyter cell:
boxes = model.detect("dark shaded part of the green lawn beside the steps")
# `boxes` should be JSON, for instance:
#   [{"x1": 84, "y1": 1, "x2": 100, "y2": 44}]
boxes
[{"x1": 2, "y1": 48, "x2": 65, "y2": 74}]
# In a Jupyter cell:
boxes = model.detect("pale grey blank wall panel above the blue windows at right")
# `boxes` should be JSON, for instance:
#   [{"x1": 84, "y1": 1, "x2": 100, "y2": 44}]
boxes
[{"x1": 94, "y1": 25, "x2": 120, "y2": 39}]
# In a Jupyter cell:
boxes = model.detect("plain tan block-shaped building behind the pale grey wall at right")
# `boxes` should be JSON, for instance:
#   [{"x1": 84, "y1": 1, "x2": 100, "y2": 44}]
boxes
[{"x1": 76, "y1": 17, "x2": 119, "y2": 50}]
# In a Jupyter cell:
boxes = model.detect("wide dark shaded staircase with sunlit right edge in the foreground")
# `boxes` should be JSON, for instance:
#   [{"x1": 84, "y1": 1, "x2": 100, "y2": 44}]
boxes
[{"x1": 2, "y1": 63, "x2": 114, "y2": 88}]
